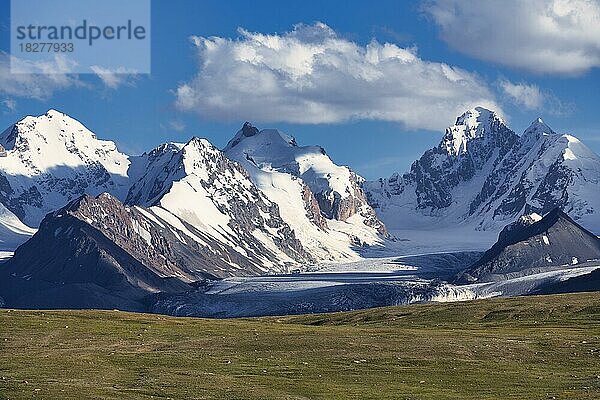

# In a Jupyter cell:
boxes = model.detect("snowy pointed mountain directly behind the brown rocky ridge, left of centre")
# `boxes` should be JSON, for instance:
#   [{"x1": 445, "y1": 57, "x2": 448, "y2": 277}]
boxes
[{"x1": 126, "y1": 138, "x2": 313, "y2": 272}]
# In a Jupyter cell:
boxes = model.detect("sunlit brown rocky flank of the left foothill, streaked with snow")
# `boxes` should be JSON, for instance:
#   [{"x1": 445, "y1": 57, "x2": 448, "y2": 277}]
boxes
[{"x1": 62, "y1": 193, "x2": 278, "y2": 282}]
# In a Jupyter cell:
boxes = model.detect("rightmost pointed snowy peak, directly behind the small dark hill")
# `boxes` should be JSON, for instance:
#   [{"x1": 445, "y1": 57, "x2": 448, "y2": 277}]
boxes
[{"x1": 469, "y1": 119, "x2": 600, "y2": 232}]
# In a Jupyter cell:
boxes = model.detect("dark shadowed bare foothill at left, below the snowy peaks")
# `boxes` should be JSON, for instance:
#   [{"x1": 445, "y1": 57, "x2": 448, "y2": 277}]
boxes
[{"x1": 0, "y1": 196, "x2": 195, "y2": 311}]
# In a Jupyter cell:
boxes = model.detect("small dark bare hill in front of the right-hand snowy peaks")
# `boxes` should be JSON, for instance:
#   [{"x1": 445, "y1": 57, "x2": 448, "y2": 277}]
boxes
[{"x1": 458, "y1": 208, "x2": 600, "y2": 282}]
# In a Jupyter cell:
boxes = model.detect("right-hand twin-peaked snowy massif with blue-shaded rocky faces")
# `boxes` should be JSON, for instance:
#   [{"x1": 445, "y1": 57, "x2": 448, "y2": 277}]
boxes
[{"x1": 364, "y1": 107, "x2": 600, "y2": 241}]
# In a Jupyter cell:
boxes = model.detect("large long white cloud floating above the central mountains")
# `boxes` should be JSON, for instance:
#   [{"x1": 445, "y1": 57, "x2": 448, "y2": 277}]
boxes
[{"x1": 175, "y1": 23, "x2": 502, "y2": 130}]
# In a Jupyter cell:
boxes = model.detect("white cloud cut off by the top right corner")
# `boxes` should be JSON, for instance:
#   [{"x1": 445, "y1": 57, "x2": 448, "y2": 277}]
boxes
[{"x1": 424, "y1": 0, "x2": 600, "y2": 75}]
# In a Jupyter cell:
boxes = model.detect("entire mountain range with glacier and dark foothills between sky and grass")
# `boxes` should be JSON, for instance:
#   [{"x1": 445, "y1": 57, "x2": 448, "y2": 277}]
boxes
[{"x1": 0, "y1": 107, "x2": 600, "y2": 317}]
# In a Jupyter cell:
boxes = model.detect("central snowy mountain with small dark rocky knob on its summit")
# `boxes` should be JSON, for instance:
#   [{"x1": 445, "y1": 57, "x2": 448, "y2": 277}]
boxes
[{"x1": 224, "y1": 122, "x2": 387, "y2": 261}]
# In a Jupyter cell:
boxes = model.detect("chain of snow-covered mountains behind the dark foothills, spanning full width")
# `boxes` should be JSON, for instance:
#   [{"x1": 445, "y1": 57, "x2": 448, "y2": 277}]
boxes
[{"x1": 0, "y1": 108, "x2": 600, "y2": 276}]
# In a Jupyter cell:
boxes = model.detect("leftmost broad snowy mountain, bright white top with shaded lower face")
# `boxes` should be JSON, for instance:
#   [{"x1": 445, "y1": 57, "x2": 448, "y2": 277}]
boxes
[{"x1": 0, "y1": 110, "x2": 130, "y2": 227}]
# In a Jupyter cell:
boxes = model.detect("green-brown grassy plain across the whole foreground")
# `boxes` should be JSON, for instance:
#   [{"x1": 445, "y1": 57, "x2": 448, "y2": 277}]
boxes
[{"x1": 0, "y1": 293, "x2": 600, "y2": 400}]
